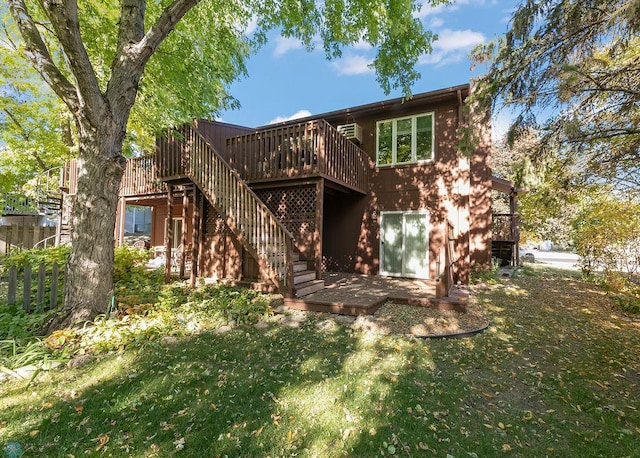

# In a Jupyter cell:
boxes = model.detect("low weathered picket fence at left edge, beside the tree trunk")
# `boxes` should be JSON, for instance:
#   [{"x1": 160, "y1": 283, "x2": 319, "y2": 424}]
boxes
[{"x1": 0, "y1": 263, "x2": 64, "y2": 313}]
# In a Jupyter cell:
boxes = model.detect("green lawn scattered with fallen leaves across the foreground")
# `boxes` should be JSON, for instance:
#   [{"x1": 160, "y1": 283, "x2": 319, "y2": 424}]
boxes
[{"x1": 0, "y1": 270, "x2": 640, "y2": 457}]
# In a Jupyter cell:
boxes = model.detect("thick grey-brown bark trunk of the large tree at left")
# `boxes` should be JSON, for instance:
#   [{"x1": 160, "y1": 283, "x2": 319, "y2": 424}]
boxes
[{"x1": 45, "y1": 120, "x2": 125, "y2": 333}]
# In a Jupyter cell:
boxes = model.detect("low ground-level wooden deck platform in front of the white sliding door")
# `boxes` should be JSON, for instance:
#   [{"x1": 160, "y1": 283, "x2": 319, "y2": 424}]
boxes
[{"x1": 285, "y1": 273, "x2": 468, "y2": 316}]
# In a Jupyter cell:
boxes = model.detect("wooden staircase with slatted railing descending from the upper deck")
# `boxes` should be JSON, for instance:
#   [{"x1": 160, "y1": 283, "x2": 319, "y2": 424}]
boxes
[{"x1": 156, "y1": 125, "x2": 324, "y2": 298}]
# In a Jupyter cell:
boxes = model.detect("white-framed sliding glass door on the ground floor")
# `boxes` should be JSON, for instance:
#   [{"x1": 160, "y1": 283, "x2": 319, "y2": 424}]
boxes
[{"x1": 380, "y1": 211, "x2": 429, "y2": 278}]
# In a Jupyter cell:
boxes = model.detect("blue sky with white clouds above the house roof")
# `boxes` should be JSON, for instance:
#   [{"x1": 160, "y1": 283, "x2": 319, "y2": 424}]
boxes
[{"x1": 219, "y1": 0, "x2": 520, "y2": 127}]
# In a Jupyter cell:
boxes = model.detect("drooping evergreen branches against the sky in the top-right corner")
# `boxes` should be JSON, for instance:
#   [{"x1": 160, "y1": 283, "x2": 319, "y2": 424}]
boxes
[{"x1": 474, "y1": 0, "x2": 640, "y2": 192}]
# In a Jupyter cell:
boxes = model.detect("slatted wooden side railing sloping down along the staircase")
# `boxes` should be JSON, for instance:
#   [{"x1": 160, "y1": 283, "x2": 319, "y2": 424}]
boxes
[{"x1": 175, "y1": 125, "x2": 294, "y2": 296}]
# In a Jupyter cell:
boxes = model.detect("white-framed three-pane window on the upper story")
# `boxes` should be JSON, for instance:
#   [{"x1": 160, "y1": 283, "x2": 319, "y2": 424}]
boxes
[{"x1": 376, "y1": 113, "x2": 434, "y2": 165}]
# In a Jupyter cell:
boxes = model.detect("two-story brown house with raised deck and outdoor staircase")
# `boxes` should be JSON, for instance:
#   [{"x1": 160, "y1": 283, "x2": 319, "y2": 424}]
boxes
[{"x1": 61, "y1": 84, "x2": 520, "y2": 310}]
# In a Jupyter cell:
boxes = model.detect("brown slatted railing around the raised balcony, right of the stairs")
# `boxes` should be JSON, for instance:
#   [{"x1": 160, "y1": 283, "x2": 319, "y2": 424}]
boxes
[{"x1": 227, "y1": 120, "x2": 369, "y2": 193}]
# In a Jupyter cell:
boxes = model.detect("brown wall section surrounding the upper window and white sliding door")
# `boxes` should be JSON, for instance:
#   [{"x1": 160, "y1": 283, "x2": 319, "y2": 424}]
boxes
[{"x1": 323, "y1": 96, "x2": 478, "y2": 281}]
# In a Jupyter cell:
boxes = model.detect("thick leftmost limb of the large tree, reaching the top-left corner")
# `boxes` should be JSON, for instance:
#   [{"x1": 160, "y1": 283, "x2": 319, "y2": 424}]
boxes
[{"x1": 9, "y1": 0, "x2": 80, "y2": 112}]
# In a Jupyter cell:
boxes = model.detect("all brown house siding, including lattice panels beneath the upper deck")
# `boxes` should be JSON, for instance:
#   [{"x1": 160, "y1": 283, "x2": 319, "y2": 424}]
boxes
[{"x1": 126, "y1": 86, "x2": 491, "y2": 282}]
